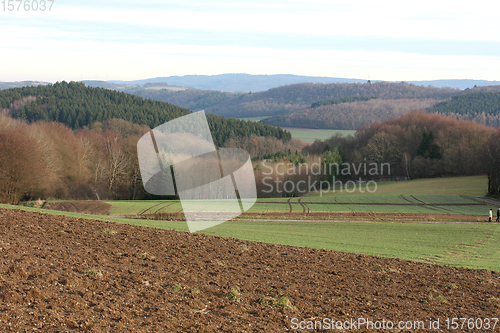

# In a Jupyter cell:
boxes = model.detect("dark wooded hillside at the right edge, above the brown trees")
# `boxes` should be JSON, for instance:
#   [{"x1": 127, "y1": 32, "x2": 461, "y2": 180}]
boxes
[{"x1": 427, "y1": 86, "x2": 500, "y2": 127}]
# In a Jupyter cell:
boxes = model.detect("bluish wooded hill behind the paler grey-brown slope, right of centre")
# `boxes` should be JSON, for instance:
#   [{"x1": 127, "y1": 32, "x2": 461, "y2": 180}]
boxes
[{"x1": 205, "y1": 82, "x2": 460, "y2": 118}]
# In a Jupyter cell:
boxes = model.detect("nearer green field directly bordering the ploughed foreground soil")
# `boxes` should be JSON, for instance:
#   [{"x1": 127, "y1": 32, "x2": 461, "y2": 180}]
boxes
[{"x1": 0, "y1": 205, "x2": 500, "y2": 271}]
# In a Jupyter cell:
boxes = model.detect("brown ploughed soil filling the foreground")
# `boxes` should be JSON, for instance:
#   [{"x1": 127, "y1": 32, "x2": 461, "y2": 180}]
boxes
[{"x1": 0, "y1": 209, "x2": 500, "y2": 332}]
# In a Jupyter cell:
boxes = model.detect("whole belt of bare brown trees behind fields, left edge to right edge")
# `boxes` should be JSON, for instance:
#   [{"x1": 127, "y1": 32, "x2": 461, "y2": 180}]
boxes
[{"x1": 0, "y1": 111, "x2": 500, "y2": 203}]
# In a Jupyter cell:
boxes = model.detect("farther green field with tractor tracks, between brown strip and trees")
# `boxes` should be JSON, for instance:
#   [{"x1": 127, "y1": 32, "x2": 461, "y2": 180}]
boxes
[{"x1": 101, "y1": 176, "x2": 491, "y2": 216}]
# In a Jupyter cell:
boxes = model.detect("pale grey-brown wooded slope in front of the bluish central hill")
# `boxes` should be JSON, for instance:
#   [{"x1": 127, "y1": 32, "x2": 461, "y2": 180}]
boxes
[{"x1": 261, "y1": 98, "x2": 437, "y2": 130}]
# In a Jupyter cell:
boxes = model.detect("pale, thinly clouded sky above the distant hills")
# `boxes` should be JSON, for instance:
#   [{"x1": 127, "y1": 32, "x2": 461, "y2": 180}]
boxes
[{"x1": 0, "y1": 0, "x2": 500, "y2": 82}]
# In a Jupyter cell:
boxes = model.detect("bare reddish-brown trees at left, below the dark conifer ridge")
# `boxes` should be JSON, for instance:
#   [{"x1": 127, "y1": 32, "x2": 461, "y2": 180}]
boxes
[{"x1": 0, "y1": 115, "x2": 149, "y2": 203}]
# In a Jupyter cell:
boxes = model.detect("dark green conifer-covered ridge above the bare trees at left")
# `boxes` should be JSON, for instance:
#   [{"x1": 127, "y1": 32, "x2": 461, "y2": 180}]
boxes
[{"x1": 0, "y1": 81, "x2": 291, "y2": 146}]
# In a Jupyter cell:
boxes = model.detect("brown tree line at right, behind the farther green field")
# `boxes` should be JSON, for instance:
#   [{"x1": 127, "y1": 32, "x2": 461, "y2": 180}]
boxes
[{"x1": 254, "y1": 111, "x2": 500, "y2": 197}]
